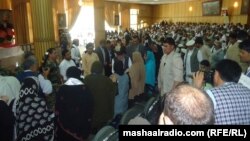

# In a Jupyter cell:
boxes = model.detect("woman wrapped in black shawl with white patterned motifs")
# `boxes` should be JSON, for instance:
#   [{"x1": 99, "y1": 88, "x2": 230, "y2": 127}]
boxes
[{"x1": 16, "y1": 77, "x2": 54, "y2": 141}]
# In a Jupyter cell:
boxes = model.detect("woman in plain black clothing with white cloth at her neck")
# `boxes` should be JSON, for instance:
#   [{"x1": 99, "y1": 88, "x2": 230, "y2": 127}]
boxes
[{"x1": 55, "y1": 66, "x2": 93, "y2": 141}]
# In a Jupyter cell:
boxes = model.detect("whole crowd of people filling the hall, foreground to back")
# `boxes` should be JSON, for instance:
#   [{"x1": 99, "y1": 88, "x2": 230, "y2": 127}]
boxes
[{"x1": 0, "y1": 21, "x2": 250, "y2": 141}]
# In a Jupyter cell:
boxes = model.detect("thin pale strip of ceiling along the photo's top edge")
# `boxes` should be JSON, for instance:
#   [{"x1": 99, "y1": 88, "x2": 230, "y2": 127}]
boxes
[{"x1": 106, "y1": 0, "x2": 191, "y2": 4}]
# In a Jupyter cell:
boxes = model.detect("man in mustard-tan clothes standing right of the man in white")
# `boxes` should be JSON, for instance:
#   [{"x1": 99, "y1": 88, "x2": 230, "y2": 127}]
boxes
[{"x1": 82, "y1": 43, "x2": 99, "y2": 77}]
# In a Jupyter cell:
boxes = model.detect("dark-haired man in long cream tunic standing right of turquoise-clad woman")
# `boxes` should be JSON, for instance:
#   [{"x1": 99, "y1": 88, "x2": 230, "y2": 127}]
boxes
[{"x1": 158, "y1": 38, "x2": 183, "y2": 96}]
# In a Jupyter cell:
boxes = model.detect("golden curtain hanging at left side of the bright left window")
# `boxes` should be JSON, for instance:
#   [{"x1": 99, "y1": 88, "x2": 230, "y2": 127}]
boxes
[{"x1": 67, "y1": 0, "x2": 81, "y2": 30}]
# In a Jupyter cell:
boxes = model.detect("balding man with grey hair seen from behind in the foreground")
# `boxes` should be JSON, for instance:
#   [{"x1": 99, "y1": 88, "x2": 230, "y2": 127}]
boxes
[{"x1": 159, "y1": 84, "x2": 214, "y2": 125}]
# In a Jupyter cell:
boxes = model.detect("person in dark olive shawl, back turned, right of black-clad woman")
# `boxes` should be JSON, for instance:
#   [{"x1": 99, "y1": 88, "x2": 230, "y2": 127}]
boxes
[{"x1": 84, "y1": 61, "x2": 116, "y2": 133}]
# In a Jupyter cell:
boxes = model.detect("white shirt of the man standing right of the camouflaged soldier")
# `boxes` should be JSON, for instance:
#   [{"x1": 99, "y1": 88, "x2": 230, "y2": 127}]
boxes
[{"x1": 59, "y1": 59, "x2": 76, "y2": 81}]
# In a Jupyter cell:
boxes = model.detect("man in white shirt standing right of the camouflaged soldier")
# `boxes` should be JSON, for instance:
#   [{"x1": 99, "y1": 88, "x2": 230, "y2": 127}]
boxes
[{"x1": 59, "y1": 49, "x2": 76, "y2": 81}]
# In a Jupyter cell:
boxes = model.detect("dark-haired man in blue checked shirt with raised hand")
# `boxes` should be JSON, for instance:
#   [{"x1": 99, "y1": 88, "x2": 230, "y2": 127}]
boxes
[{"x1": 194, "y1": 59, "x2": 250, "y2": 125}]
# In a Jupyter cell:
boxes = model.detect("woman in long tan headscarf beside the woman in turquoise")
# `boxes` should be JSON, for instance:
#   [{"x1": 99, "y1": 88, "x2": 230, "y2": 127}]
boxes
[{"x1": 128, "y1": 52, "x2": 145, "y2": 100}]
